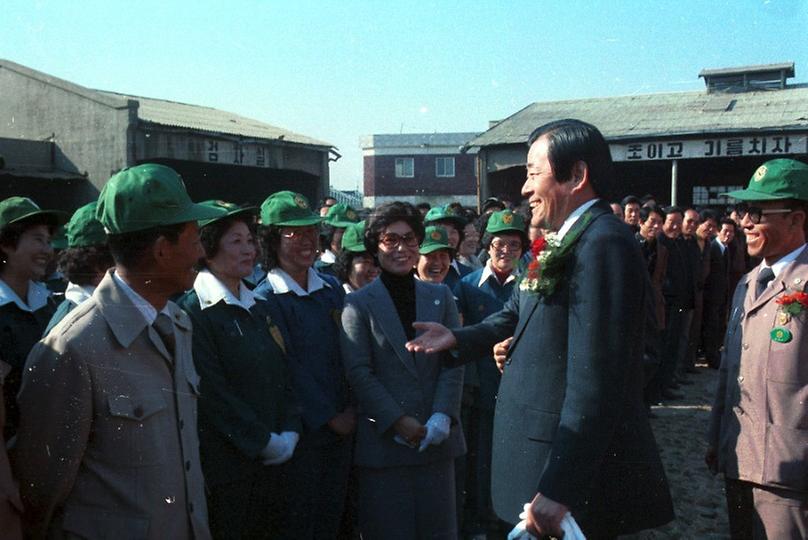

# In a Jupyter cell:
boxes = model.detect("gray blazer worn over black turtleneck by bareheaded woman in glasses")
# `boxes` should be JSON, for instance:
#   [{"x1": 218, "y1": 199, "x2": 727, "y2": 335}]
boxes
[{"x1": 341, "y1": 279, "x2": 466, "y2": 467}]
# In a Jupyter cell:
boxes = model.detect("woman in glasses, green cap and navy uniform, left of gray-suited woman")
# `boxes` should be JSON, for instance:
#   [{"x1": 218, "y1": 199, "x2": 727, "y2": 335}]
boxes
[{"x1": 256, "y1": 191, "x2": 356, "y2": 539}]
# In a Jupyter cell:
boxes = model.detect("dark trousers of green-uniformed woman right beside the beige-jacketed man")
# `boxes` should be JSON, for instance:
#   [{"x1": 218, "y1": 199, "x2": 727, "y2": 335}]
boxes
[{"x1": 208, "y1": 465, "x2": 287, "y2": 540}]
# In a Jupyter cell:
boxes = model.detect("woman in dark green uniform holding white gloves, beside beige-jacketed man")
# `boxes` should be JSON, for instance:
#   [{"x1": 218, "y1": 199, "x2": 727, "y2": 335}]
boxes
[{"x1": 179, "y1": 201, "x2": 301, "y2": 538}]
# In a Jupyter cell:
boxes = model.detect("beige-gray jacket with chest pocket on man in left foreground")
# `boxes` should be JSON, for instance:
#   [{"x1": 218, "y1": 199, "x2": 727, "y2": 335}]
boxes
[{"x1": 15, "y1": 274, "x2": 210, "y2": 540}]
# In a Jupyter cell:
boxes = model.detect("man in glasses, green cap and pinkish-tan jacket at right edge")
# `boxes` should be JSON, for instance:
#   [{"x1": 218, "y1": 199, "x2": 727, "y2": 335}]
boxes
[{"x1": 705, "y1": 159, "x2": 808, "y2": 538}]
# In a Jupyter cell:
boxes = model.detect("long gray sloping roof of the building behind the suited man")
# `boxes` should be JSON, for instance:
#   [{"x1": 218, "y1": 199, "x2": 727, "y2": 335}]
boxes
[{"x1": 469, "y1": 85, "x2": 808, "y2": 146}]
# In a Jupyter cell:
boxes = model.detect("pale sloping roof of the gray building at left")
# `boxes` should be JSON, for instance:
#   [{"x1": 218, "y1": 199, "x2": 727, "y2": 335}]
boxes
[{"x1": 98, "y1": 90, "x2": 331, "y2": 147}]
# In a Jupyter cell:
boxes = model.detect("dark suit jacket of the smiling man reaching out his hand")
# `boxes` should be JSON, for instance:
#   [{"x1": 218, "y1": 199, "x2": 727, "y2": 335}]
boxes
[{"x1": 454, "y1": 201, "x2": 673, "y2": 535}]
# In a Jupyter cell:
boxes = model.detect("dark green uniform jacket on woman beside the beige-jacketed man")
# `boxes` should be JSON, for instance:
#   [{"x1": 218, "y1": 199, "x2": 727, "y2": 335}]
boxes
[{"x1": 179, "y1": 290, "x2": 302, "y2": 485}]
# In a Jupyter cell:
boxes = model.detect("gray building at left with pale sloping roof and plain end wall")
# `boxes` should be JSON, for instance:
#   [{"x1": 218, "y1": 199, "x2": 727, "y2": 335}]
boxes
[{"x1": 0, "y1": 60, "x2": 338, "y2": 209}]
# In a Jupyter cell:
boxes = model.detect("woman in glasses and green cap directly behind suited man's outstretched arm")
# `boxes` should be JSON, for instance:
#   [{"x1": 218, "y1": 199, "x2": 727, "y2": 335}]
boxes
[{"x1": 454, "y1": 210, "x2": 528, "y2": 537}]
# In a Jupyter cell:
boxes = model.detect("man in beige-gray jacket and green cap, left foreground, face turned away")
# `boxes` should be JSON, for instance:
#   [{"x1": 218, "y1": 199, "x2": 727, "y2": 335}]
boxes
[{"x1": 15, "y1": 164, "x2": 223, "y2": 539}]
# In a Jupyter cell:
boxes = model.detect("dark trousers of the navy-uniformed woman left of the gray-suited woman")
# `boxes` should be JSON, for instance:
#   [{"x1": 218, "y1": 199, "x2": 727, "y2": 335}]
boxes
[{"x1": 284, "y1": 427, "x2": 353, "y2": 540}]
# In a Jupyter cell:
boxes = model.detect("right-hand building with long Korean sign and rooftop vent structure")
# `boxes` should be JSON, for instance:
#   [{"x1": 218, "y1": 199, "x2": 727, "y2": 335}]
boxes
[{"x1": 469, "y1": 63, "x2": 808, "y2": 205}]
